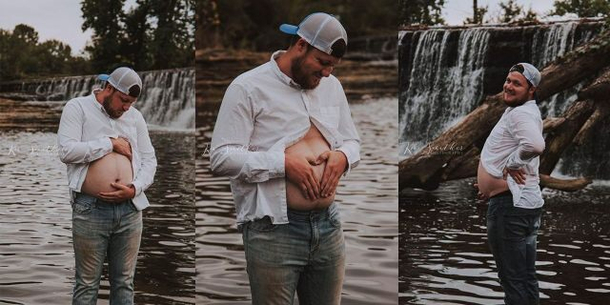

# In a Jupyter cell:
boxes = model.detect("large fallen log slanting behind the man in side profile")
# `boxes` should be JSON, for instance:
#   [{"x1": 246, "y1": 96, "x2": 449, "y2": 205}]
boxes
[{"x1": 399, "y1": 31, "x2": 610, "y2": 190}]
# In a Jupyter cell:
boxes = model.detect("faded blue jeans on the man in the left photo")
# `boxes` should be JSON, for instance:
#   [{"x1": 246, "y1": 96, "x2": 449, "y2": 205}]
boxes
[{"x1": 72, "y1": 193, "x2": 142, "y2": 305}]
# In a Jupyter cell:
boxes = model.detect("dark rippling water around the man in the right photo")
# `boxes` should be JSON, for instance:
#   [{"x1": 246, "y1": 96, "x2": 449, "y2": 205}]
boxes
[{"x1": 399, "y1": 179, "x2": 610, "y2": 305}]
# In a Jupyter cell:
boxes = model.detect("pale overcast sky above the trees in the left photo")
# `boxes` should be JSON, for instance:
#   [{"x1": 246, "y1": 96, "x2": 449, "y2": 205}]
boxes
[{"x1": 0, "y1": 0, "x2": 135, "y2": 55}]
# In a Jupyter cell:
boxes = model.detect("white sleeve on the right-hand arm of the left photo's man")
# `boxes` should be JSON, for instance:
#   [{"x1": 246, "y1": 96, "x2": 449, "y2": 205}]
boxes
[{"x1": 132, "y1": 114, "x2": 157, "y2": 196}]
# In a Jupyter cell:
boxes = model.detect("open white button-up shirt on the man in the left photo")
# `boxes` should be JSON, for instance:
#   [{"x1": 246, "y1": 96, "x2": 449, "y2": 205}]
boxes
[{"x1": 57, "y1": 91, "x2": 157, "y2": 210}]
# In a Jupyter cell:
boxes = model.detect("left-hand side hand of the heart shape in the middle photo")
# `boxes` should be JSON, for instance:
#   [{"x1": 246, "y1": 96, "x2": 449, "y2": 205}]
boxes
[{"x1": 284, "y1": 154, "x2": 320, "y2": 200}]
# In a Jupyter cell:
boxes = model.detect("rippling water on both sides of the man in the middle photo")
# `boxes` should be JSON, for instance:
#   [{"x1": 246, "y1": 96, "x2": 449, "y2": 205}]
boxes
[{"x1": 196, "y1": 99, "x2": 398, "y2": 305}]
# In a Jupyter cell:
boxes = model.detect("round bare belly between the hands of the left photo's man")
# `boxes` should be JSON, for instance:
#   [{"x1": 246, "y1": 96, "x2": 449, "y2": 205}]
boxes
[{"x1": 81, "y1": 152, "x2": 133, "y2": 196}]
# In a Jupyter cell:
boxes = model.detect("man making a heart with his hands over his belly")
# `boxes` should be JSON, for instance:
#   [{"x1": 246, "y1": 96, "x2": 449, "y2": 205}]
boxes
[{"x1": 211, "y1": 13, "x2": 360, "y2": 305}]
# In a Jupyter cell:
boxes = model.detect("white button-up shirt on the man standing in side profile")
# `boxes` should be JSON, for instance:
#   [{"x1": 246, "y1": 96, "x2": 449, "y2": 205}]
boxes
[{"x1": 481, "y1": 100, "x2": 544, "y2": 209}]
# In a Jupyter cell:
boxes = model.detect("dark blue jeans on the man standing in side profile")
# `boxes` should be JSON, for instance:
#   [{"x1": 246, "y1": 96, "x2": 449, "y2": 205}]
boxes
[{"x1": 487, "y1": 195, "x2": 542, "y2": 305}]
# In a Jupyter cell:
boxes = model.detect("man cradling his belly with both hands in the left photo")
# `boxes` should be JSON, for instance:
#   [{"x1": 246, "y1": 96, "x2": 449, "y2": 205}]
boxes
[{"x1": 57, "y1": 67, "x2": 157, "y2": 304}]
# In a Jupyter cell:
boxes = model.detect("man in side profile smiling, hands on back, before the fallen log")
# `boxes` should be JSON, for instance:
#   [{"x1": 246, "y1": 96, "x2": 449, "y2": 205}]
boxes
[{"x1": 477, "y1": 63, "x2": 544, "y2": 305}]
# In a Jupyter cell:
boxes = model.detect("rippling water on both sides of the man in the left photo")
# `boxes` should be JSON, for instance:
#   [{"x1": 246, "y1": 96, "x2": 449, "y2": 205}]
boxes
[{"x1": 0, "y1": 130, "x2": 195, "y2": 305}]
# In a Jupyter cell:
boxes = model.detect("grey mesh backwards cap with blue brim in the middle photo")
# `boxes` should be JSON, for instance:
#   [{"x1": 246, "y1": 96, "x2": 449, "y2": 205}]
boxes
[{"x1": 280, "y1": 13, "x2": 347, "y2": 57}]
